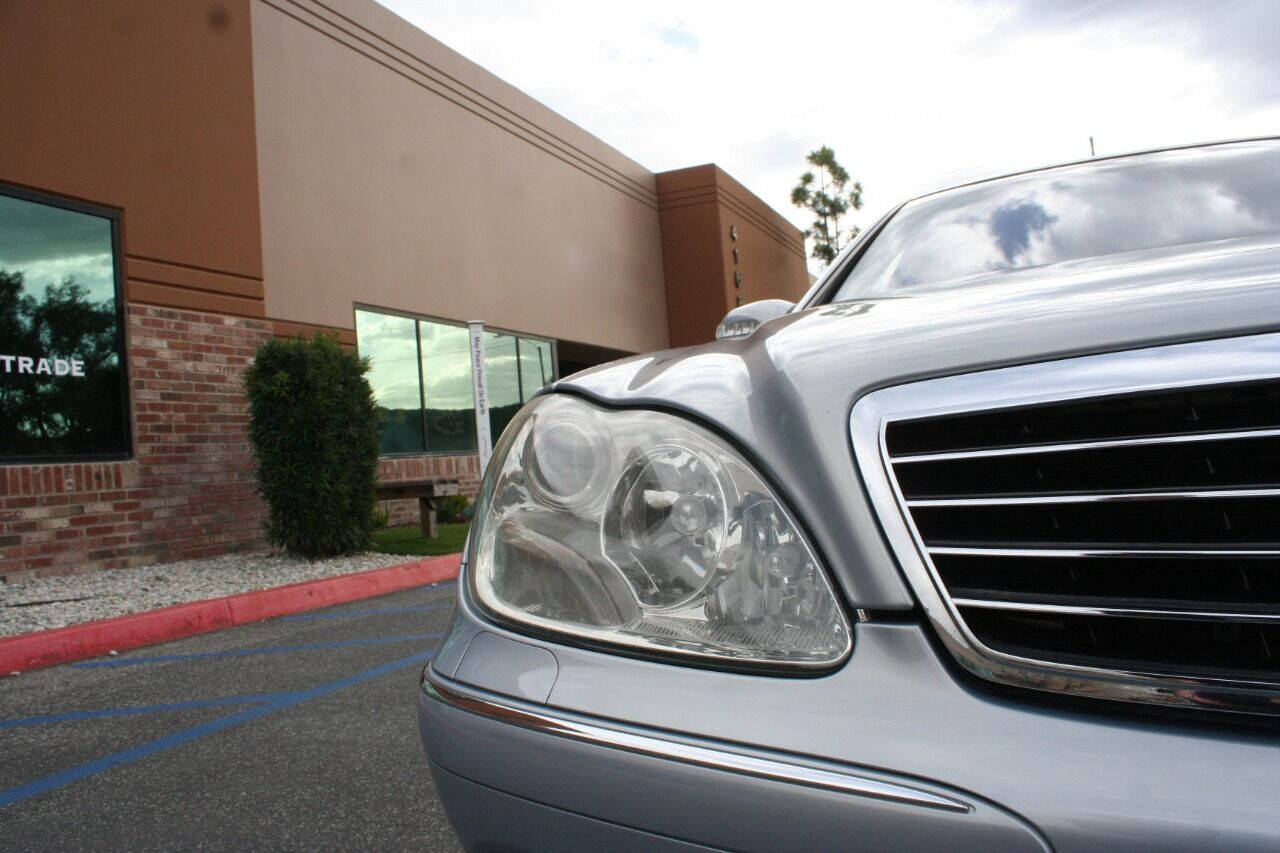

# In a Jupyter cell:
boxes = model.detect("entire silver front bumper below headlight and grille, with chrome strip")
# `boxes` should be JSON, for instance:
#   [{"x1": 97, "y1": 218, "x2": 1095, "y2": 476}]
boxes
[{"x1": 419, "y1": 581, "x2": 1280, "y2": 850}]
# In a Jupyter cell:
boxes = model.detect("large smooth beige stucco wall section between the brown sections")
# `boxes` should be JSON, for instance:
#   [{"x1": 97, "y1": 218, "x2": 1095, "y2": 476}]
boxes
[{"x1": 252, "y1": 0, "x2": 668, "y2": 351}]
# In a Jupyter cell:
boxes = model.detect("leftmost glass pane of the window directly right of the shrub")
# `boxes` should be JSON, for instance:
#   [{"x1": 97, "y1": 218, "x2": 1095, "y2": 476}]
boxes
[{"x1": 356, "y1": 311, "x2": 426, "y2": 453}]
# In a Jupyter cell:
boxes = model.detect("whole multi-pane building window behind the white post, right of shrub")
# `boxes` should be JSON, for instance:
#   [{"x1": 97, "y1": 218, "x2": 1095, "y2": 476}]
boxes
[{"x1": 356, "y1": 303, "x2": 556, "y2": 455}]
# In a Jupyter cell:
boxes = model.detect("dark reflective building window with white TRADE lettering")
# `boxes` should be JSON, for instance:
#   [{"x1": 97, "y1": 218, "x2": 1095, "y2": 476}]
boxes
[{"x1": 0, "y1": 187, "x2": 129, "y2": 462}]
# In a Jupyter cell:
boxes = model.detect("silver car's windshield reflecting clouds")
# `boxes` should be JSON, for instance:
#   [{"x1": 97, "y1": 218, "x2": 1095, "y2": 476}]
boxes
[{"x1": 832, "y1": 141, "x2": 1280, "y2": 302}]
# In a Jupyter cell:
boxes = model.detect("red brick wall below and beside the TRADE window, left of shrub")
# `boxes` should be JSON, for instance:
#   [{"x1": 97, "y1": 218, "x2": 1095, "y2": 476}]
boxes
[{"x1": 0, "y1": 305, "x2": 271, "y2": 575}]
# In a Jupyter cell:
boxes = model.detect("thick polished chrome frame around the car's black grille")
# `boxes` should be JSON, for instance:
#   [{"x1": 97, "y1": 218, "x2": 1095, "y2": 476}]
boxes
[{"x1": 849, "y1": 332, "x2": 1280, "y2": 715}]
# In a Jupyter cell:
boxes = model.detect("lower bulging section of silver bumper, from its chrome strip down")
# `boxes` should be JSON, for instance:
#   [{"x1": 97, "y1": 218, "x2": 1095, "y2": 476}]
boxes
[{"x1": 420, "y1": 672, "x2": 1046, "y2": 850}]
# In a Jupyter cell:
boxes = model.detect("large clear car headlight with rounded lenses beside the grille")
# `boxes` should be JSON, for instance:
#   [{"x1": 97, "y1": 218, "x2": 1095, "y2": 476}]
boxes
[{"x1": 470, "y1": 394, "x2": 851, "y2": 667}]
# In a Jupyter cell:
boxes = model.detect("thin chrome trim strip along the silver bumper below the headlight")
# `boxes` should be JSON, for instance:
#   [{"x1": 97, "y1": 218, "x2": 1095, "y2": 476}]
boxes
[{"x1": 422, "y1": 667, "x2": 974, "y2": 815}]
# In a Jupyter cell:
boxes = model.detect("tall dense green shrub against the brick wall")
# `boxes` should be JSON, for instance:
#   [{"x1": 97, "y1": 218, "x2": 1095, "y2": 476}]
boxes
[{"x1": 244, "y1": 334, "x2": 378, "y2": 560}]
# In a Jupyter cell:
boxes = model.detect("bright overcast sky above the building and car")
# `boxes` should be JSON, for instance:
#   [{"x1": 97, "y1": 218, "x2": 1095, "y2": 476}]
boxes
[{"x1": 381, "y1": 0, "x2": 1280, "y2": 268}]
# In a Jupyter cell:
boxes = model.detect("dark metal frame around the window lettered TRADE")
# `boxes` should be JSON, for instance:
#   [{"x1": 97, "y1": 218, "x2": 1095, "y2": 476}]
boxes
[{"x1": 0, "y1": 181, "x2": 134, "y2": 466}]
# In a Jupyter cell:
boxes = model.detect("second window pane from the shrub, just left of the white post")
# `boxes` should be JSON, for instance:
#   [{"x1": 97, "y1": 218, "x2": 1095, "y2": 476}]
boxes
[{"x1": 419, "y1": 320, "x2": 476, "y2": 453}]
